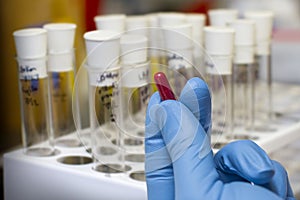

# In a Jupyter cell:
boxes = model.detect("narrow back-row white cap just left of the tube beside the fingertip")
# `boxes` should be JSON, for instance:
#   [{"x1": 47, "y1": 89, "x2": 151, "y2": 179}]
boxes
[{"x1": 186, "y1": 13, "x2": 206, "y2": 44}]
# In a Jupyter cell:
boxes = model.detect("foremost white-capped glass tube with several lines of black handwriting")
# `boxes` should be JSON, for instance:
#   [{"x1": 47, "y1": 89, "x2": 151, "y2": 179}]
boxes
[{"x1": 84, "y1": 30, "x2": 128, "y2": 174}]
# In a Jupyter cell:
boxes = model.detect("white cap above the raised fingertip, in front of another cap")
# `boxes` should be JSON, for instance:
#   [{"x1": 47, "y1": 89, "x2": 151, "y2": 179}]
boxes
[{"x1": 163, "y1": 24, "x2": 193, "y2": 50}]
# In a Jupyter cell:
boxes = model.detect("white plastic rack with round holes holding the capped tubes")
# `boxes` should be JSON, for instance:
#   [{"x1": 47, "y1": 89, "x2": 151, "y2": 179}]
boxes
[{"x1": 4, "y1": 83, "x2": 300, "y2": 200}]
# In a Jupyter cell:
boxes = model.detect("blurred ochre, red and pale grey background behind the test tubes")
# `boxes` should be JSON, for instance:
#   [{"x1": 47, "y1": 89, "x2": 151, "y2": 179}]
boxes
[{"x1": 0, "y1": 0, "x2": 300, "y2": 196}]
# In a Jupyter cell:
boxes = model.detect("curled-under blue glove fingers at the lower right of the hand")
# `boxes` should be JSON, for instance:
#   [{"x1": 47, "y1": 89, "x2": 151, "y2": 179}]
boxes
[{"x1": 214, "y1": 140, "x2": 294, "y2": 200}]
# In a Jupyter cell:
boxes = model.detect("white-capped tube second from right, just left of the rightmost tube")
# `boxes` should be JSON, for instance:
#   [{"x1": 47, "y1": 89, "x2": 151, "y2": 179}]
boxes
[{"x1": 229, "y1": 19, "x2": 255, "y2": 130}]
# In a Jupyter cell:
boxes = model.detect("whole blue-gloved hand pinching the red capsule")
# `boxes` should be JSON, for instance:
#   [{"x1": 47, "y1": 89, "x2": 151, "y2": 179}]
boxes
[{"x1": 145, "y1": 78, "x2": 295, "y2": 200}]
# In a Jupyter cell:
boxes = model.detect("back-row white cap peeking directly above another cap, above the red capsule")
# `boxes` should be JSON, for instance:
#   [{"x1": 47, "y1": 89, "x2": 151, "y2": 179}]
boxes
[{"x1": 158, "y1": 12, "x2": 186, "y2": 27}]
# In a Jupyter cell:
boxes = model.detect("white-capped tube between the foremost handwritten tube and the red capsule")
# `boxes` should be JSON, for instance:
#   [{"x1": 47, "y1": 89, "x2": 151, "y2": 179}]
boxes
[{"x1": 120, "y1": 35, "x2": 150, "y2": 153}]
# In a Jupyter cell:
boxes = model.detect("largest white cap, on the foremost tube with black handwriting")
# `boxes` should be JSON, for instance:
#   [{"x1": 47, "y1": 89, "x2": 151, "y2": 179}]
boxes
[{"x1": 83, "y1": 30, "x2": 121, "y2": 70}]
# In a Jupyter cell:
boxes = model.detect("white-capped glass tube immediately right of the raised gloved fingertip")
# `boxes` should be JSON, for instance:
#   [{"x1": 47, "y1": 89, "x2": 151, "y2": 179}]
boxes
[{"x1": 204, "y1": 27, "x2": 234, "y2": 137}]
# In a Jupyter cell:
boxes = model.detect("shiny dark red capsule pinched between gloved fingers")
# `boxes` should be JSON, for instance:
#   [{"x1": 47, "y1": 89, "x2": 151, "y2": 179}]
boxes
[{"x1": 154, "y1": 72, "x2": 176, "y2": 101}]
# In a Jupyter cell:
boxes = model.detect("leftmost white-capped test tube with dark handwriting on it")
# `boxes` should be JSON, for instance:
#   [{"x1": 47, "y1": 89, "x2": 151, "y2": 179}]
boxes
[{"x1": 13, "y1": 28, "x2": 54, "y2": 156}]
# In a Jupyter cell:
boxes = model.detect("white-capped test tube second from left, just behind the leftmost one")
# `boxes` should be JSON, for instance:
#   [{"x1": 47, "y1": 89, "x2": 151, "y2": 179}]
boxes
[{"x1": 43, "y1": 23, "x2": 80, "y2": 147}]
